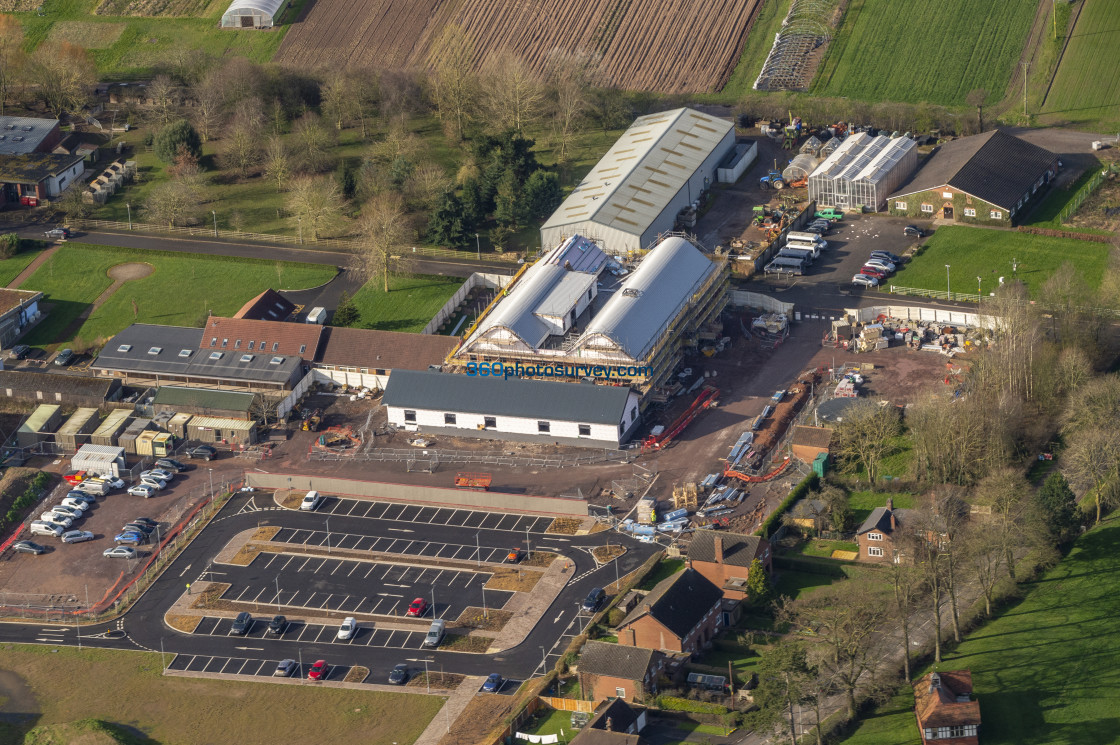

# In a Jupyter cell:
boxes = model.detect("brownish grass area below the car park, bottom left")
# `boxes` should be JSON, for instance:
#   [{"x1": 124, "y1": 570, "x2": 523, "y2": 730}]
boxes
[{"x1": 0, "y1": 644, "x2": 442, "y2": 745}]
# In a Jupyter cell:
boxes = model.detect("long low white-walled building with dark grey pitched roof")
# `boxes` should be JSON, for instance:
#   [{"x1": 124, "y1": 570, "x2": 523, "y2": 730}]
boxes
[{"x1": 383, "y1": 370, "x2": 641, "y2": 448}]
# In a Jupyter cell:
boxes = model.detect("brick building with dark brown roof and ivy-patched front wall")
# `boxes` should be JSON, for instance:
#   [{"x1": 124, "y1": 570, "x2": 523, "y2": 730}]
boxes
[{"x1": 887, "y1": 130, "x2": 1057, "y2": 227}]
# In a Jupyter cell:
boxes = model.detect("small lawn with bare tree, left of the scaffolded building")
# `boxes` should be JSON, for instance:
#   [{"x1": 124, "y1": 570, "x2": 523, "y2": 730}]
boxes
[{"x1": 354, "y1": 274, "x2": 463, "y2": 332}]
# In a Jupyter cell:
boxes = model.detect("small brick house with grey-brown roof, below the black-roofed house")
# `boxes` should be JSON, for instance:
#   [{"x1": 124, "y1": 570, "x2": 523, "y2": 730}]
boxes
[{"x1": 579, "y1": 642, "x2": 665, "y2": 701}]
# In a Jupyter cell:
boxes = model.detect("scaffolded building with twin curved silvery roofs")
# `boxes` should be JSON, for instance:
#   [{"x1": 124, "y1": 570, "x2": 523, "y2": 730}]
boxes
[{"x1": 452, "y1": 236, "x2": 728, "y2": 390}]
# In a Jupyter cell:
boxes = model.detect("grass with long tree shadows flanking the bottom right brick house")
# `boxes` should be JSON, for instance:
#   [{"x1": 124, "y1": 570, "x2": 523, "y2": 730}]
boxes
[{"x1": 844, "y1": 516, "x2": 1120, "y2": 745}]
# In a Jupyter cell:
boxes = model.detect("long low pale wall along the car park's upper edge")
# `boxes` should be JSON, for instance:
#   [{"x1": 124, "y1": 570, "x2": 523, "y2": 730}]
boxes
[{"x1": 245, "y1": 471, "x2": 587, "y2": 518}]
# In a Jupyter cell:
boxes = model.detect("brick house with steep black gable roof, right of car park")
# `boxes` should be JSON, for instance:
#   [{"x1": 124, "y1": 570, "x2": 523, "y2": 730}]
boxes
[{"x1": 618, "y1": 568, "x2": 724, "y2": 654}]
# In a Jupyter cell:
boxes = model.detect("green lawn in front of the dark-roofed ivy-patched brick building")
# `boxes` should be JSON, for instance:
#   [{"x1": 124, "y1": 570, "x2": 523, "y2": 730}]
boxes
[{"x1": 889, "y1": 225, "x2": 1109, "y2": 296}]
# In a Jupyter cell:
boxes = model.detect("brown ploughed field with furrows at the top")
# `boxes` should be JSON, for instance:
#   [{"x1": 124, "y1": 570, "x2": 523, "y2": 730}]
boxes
[{"x1": 278, "y1": 0, "x2": 759, "y2": 93}]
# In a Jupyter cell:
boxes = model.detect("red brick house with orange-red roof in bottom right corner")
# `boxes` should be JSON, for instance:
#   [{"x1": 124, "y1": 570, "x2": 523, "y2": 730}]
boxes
[{"x1": 914, "y1": 670, "x2": 980, "y2": 745}]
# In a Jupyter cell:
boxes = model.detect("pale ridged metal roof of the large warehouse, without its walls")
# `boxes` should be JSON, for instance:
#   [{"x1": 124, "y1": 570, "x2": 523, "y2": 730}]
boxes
[{"x1": 542, "y1": 109, "x2": 732, "y2": 235}]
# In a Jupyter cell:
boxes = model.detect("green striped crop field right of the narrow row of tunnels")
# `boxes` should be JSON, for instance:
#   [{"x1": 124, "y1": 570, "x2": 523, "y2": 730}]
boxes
[{"x1": 812, "y1": 0, "x2": 1030, "y2": 105}]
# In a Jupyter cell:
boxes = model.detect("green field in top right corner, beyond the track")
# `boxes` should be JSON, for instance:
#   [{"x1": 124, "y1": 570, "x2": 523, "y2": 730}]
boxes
[{"x1": 1043, "y1": 0, "x2": 1120, "y2": 131}]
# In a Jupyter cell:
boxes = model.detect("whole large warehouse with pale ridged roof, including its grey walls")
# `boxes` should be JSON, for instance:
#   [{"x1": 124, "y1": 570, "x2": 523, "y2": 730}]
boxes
[{"x1": 541, "y1": 109, "x2": 735, "y2": 254}]
